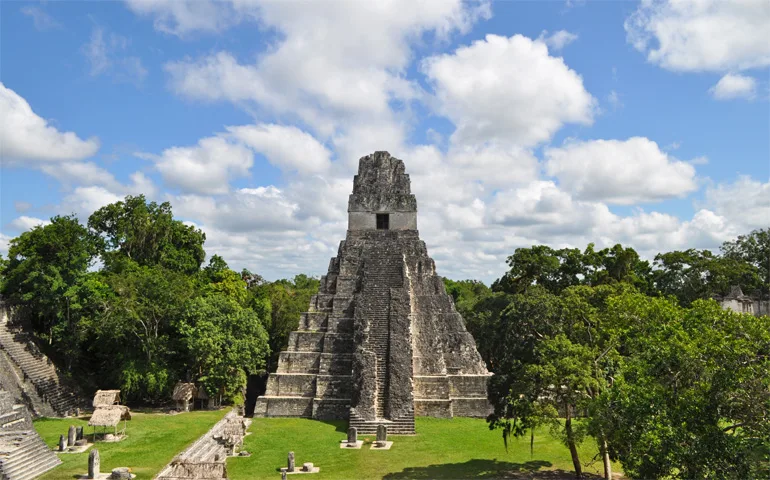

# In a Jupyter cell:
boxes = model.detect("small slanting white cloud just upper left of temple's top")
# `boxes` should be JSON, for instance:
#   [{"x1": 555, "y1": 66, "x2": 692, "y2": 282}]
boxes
[{"x1": 227, "y1": 124, "x2": 331, "y2": 174}]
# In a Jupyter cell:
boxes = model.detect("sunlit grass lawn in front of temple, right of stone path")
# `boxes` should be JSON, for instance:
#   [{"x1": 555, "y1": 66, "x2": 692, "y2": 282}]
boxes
[{"x1": 227, "y1": 417, "x2": 619, "y2": 480}]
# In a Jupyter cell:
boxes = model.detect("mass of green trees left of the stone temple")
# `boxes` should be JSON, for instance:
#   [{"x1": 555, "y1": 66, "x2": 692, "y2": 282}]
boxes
[{"x1": 0, "y1": 196, "x2": 271, "y2": 403}]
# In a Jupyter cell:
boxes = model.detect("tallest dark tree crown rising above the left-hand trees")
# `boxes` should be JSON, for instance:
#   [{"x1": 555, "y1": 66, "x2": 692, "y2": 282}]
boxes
[{"x1": 88, "y1": 195, "x2": 206, "y2": 273}]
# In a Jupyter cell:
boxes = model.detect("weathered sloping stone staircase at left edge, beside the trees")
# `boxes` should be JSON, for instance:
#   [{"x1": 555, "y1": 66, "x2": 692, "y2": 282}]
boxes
[{"x1": 0, "y1": 305, "x2": 79, "y2": 416}]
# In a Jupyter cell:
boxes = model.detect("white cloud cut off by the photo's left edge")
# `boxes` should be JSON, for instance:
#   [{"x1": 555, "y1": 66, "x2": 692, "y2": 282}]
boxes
[{"x1": 0, "y1": 83, "x2": 99, "y2": 165}]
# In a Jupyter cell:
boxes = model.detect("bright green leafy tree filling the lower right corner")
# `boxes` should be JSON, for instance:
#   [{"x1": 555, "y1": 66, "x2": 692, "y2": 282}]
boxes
[{"x1": 591, "y1": 294, "x2": 770, "y2": 478}]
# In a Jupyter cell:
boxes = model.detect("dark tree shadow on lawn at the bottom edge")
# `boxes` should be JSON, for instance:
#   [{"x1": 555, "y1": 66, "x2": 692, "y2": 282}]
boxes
[{"x1": 382, "y1": 459, "x2": 601, "y2": 480}]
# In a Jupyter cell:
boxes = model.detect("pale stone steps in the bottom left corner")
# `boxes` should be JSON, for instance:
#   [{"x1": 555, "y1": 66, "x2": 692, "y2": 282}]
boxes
[{"x1": 0, "y1": 390, "x2": 61, "y2": 480}]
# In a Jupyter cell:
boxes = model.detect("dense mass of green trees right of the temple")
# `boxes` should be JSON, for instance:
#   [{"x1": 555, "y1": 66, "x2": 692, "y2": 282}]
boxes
[{"x1": 446, "y1": 230, "x2": 770, "y2": 478}]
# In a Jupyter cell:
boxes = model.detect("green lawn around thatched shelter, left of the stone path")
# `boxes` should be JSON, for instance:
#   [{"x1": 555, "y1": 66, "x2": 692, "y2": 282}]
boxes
[{"x1": 35, "y1": 409, "x2": 228, "y2": 480}]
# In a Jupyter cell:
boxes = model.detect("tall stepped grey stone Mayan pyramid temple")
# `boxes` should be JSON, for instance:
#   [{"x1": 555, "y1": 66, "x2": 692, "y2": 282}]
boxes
[{"x1": 254, "y1": 152, "x2": 490, "y2": 434}]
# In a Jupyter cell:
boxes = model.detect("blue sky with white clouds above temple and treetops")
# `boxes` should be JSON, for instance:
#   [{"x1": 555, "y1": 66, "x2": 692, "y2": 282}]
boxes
[{"x1": 0, "y1": 0, "x2": 770, "y2": 281}]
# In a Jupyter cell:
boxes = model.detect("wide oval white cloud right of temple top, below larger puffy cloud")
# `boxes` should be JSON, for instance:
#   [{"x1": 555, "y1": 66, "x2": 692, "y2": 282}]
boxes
[{"x1": 544, "y1": 137, "x2": 697, "y2": 205}]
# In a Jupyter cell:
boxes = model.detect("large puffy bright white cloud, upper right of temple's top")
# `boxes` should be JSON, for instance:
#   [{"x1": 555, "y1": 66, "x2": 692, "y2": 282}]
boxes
[{"x1": 422, "y1": 35, "x2": 596, "y2": 146}]
